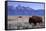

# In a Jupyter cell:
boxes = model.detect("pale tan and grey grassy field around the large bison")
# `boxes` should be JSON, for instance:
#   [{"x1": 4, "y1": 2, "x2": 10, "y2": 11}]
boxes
[{"x1": 7, "y1": 16, "x2": 45, "y2": 30}]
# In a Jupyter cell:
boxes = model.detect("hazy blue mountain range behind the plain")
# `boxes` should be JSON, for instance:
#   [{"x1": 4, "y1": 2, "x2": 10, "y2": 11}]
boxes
[{"x1": 8, "y1": 6, "x2": 45, "y2": 16}]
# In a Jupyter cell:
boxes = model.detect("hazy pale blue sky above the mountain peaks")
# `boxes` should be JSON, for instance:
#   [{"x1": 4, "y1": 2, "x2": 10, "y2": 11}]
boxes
[{"x1": 8, "y1": 2, "x2": 44, "y2": 10}]
